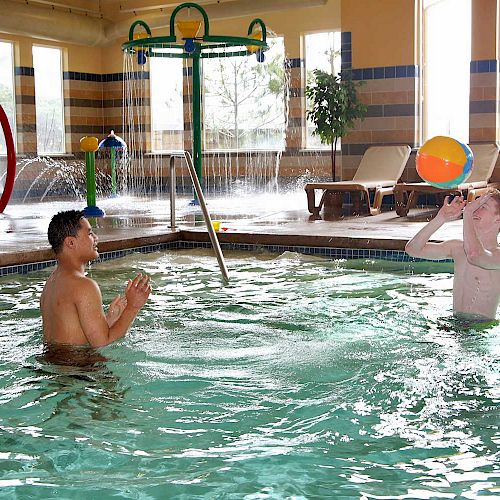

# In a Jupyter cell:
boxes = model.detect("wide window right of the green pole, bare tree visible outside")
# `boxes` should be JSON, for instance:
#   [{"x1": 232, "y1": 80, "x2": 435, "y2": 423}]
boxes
[{"x1": 203, "y1": 37, "x2": 286, "y2": 151}]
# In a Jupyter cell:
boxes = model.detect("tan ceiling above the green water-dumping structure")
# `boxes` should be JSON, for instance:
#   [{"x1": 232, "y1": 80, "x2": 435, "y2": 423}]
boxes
[{"x1": 4, "y1": 0, "x2": 328, "y2": 46}]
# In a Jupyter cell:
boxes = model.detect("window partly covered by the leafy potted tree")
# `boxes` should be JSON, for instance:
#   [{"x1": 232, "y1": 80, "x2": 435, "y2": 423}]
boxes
[{"x1": 305, "y1": 31, "x2": 340, "y2": 149}]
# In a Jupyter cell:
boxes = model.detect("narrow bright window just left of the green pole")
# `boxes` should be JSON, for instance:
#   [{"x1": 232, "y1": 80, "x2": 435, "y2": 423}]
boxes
[{"x1": 149, "y1": 57, "x2": 184, "y2": 152}]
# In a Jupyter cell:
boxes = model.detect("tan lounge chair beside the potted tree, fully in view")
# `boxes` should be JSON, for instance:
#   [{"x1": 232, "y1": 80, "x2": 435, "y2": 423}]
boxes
[{"x1": 304, "y1": 145, "x2": 411, "y2": 219}]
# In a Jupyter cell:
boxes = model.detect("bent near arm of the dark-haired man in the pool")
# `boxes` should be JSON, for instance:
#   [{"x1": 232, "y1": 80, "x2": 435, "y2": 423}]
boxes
[{"x1": 76, "y1": 274, "x2": 151, "y2": 347}]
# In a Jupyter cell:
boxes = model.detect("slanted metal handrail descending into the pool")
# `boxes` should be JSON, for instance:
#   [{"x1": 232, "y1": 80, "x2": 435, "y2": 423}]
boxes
[{"x1": 170, "y1": 151, "x2": 229, "y2": 283}]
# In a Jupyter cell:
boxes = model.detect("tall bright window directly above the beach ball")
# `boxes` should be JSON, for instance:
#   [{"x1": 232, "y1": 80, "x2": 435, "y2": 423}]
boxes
[{"x1": 423, "y1": 0, "x2": 471, "y2": 143}]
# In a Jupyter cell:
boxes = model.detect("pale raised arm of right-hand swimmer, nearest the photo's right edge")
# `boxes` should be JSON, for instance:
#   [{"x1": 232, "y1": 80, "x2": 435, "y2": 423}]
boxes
[{"x1": 464, "y1": 195, "x2": 500, "y2": 269}]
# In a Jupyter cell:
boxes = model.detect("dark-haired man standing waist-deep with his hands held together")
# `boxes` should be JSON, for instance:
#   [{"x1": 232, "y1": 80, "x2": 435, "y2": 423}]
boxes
[{"x1": 40, "y1": 210, "x2": 151, "y2": 347}]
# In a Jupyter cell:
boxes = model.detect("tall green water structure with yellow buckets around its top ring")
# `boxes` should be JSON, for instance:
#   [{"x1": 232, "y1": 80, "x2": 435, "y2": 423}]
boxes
[{"x1": 122, "y1": 2, "x2": 269, "y2": 189}]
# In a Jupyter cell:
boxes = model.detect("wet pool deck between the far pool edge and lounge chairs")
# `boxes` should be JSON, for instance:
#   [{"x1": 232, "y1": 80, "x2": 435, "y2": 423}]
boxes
[{"x1": 0, "y1": 193, "x2": 462, "y2": 267}]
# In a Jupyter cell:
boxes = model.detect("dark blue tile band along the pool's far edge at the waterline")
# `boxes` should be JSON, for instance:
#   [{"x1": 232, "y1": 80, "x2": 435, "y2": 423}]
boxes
[{"x1": 0, "y1": 241, "x2": 451, "y2": 277}]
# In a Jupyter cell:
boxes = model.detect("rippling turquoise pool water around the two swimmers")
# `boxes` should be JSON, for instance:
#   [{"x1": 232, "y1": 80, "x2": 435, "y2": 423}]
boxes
[{"x1": 0, "y1": 250, "x2": 500, "y2": 499}]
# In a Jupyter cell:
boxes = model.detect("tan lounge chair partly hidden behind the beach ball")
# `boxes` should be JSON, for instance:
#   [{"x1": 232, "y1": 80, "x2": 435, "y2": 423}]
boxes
[{"x1": 394, "y1": 144, "x2": 498, "y2": 217}]
